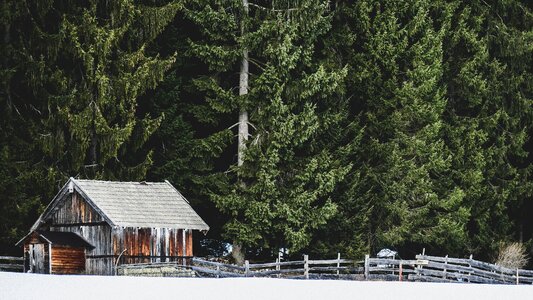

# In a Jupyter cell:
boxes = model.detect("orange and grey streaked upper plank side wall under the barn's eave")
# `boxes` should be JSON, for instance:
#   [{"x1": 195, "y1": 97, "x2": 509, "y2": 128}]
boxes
[{"x1": 113, "y1": 227, "x2": 193, "y2": 264}]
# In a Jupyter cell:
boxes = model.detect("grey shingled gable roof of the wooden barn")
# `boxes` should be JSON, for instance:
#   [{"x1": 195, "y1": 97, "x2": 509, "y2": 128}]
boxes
[{"x1": 28, "y1": 178, "x2": 209, "y2": 231}]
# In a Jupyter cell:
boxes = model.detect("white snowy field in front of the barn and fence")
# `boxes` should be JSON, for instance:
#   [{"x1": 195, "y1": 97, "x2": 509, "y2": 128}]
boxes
[{"x1": 0, "y1": 272, "x2": 533, "y2": 300}]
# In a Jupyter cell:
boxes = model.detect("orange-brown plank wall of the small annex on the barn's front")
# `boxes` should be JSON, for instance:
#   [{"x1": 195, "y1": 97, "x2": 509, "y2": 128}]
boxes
[{"x1": 52, "y1": 246, "x2": 85, "y2": 274}]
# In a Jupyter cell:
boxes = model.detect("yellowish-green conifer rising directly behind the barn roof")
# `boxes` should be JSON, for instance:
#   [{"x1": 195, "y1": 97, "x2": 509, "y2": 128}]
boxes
[{"x1": 35, "y1": 0, "x2": 178, "y2": 179}]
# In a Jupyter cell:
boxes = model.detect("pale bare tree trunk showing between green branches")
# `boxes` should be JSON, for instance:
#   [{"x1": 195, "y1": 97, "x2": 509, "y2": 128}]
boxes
[{"x1": 231, "y1": 0, "x2": 248, "y2": 265}]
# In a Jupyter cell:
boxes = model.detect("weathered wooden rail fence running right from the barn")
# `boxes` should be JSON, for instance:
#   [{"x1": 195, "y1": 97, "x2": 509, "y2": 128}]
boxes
[{"x1": 191, "y1": 255, "x2": 533, "y2": 284}]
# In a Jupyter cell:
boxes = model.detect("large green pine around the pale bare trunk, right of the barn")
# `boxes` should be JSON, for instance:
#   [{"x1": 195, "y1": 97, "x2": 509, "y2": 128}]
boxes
[{"x1": 181, "y1": 1, "x2": 350, "y2": 255}]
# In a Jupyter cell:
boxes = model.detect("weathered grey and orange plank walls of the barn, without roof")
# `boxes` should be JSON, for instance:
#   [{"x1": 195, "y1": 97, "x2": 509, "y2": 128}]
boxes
[{"x1": 33, "y1": 192, "x2": 198, "y2": 275}]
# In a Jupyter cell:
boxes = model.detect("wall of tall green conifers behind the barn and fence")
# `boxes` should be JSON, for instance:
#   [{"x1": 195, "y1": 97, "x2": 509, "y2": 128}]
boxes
[{"x1": 0, "y1": 0, "x2": 533, "y2": 259}]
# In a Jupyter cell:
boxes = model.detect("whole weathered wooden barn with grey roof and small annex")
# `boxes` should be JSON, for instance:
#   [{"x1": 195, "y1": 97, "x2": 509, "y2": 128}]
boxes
[{"x1": 17, "y1": 178, "x2": 209, "y2": 275}]
